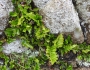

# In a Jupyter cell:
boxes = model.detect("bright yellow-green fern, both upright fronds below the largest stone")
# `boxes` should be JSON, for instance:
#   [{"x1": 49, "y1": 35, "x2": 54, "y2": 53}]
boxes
[{"x1": 46, "y1": 34, "x2": 64, "y2": 65}]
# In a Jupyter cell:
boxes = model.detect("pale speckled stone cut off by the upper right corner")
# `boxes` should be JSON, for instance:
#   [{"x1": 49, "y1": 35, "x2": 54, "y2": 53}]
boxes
[{"x1": 75, "y1": 0, "x2": 90, "y2": 23}]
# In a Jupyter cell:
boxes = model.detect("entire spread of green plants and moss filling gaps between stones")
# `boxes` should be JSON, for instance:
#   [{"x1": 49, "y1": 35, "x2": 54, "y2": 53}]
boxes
[{"x1": 0, "y1": 0, "x2": 90, "y2": 70}]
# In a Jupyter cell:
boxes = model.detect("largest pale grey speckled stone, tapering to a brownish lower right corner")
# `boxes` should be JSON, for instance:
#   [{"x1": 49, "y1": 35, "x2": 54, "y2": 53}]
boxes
[{"x1": 33, "y1": 0, "x2": 84, "y2": 43}]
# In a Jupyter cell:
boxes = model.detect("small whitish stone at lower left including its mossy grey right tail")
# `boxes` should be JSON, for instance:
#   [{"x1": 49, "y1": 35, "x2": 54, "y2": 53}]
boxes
[{"x1": 2, "y1": 39, "x2": 39, "y2": 57}]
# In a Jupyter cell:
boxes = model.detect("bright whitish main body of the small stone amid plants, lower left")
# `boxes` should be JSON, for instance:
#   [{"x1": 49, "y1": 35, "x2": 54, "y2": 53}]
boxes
[{"x1": 3, "y1": 39, "x2": 26, "y2": 55}]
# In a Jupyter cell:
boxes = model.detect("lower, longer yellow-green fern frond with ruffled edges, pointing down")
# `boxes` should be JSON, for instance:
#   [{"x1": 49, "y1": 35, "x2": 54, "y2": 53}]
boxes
[{"x1": 46, "y1": 46, "x2": 58, "y2": 65}]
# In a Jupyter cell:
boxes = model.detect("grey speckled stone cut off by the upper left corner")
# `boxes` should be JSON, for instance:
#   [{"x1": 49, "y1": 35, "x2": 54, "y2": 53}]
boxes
[{"x1": 0, "y1": 0, "x2": 13, "y2": 35}]
